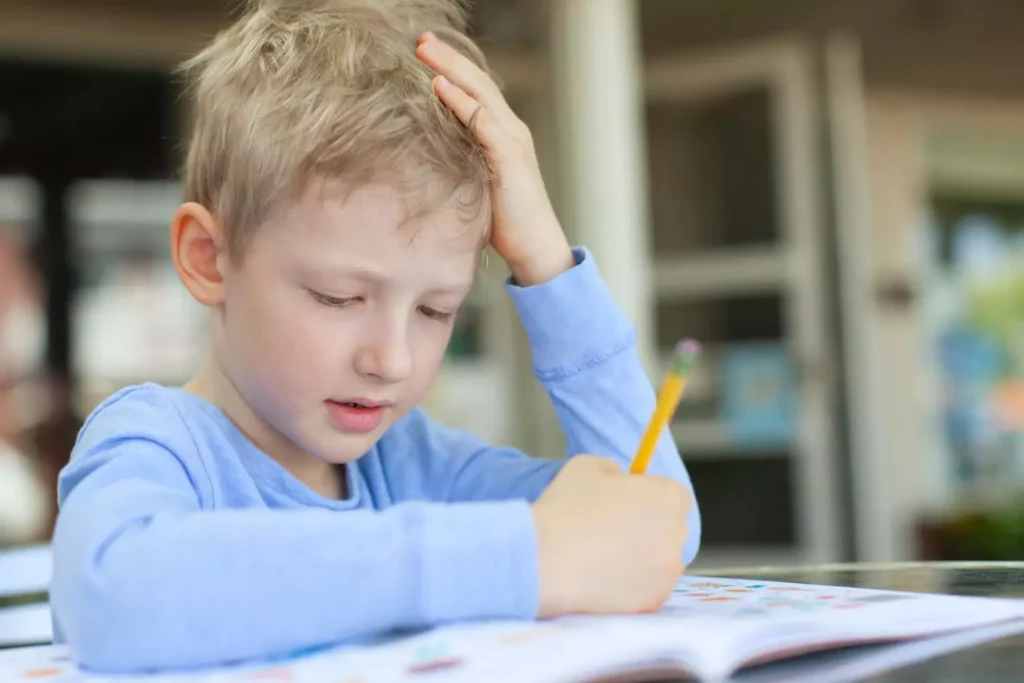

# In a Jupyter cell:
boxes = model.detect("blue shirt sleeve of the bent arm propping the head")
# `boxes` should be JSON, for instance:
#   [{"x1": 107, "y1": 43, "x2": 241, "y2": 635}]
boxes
[{"x1": 389, "y1": 248, "x2": 700, "y2": 564}]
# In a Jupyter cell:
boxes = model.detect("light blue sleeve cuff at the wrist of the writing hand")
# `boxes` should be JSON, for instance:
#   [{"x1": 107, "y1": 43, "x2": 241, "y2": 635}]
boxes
[{"x1": 420, "y1": 501, "x2": 540, "y2": 624}]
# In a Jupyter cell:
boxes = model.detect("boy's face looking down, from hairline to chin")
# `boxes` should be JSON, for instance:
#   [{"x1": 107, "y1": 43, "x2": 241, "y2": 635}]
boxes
[{"x1": 212, "y1": 183, "x2": 481, "y2": 463}]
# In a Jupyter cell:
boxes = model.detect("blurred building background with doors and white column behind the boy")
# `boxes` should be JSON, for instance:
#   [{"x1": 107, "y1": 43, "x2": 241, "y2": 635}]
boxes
[{"x1": 0, "y1": 0, "x2": 1024, "y2": 566}]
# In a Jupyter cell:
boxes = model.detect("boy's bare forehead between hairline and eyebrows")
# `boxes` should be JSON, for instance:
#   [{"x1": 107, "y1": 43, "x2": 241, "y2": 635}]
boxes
[{"x1": 268, "y1": 180, "x2": 489, "y2": 287}]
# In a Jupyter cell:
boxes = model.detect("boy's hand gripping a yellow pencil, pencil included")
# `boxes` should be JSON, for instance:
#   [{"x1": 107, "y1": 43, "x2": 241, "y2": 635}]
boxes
[{"x1": 532, "y1": 341, "x2": 699, "y2": 617}]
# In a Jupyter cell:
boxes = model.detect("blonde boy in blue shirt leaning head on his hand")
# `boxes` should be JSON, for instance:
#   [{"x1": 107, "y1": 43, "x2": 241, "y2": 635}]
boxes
[{"x1": 51, "y1": 0, "x2": 699, "y2": 671}]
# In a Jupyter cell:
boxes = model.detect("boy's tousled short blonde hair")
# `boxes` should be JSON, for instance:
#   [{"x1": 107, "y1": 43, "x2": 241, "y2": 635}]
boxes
[{"x1": 181, "y1": 0, "x2": 489, "y2": 254}]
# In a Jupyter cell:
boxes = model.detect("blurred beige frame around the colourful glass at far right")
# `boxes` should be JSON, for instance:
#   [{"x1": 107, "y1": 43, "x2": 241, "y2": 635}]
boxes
[{"x1": 854, "y1": 83, "x2": 1024, "y2": 561}]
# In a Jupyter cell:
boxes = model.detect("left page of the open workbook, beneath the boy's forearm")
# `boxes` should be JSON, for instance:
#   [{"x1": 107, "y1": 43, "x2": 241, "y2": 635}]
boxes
[{"x1": 0, "y1": 622, "x2": 692, "y2": 683}]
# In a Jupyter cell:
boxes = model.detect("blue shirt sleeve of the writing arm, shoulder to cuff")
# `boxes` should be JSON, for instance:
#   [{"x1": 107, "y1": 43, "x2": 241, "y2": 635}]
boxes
[{"x1": 50, "y1": 395, "x2": 539, "y2": 673}]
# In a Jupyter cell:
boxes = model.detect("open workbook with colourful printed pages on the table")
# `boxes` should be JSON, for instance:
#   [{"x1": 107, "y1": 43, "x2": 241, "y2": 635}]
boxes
[{"x1": 6, "y1": 577, "x2": 1024, "y2": 683}]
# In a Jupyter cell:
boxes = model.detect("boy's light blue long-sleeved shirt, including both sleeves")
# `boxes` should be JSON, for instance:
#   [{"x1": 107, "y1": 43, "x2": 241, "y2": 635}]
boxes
[{"x1": 51, "y1": 249, "x2": 700, "y2": 672}]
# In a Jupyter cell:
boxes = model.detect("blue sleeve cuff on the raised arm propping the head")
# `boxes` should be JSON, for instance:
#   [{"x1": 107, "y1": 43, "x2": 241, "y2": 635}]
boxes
[{"x1": 505, "y1": 247, "x2": 635, "y2": 375}]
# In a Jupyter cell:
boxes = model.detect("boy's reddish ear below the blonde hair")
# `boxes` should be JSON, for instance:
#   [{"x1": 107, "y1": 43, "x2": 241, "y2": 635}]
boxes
[{"x1": 171, "y1": 202, "x2": 226, "y2": 306}]
